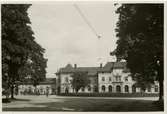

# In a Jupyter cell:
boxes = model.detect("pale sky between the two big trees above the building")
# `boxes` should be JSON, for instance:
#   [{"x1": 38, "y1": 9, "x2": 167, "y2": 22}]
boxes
[{"x1": 28, "y1": 1, "x2": 118, "y2": 77}]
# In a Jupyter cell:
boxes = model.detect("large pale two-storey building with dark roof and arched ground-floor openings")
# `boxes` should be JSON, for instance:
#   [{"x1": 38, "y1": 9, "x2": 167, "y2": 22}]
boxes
[{"x1": 56, "y1": 62, "x2": 159, "y2": 93}]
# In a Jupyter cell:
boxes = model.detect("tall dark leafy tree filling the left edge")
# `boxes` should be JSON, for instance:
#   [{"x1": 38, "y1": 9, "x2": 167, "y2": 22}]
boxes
[{"x1": 1, "y1": 4, "x2": 46, "y2": 98}]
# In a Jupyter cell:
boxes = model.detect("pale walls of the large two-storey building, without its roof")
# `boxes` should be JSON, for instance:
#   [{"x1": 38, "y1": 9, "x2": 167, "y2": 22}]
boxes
[{"x1": 60, "y1": 69, "x2": 159, "y2": 93}]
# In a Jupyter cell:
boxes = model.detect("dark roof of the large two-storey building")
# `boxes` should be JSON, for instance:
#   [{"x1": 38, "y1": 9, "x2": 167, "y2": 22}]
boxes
[{"x1": 59, "y1": 62, "x2": 126, "y2": 75}]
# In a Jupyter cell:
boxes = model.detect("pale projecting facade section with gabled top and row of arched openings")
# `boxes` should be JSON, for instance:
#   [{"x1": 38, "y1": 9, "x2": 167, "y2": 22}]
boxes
[{"x1": 98, "y1": 69, "x2": 134, "y2": 93}]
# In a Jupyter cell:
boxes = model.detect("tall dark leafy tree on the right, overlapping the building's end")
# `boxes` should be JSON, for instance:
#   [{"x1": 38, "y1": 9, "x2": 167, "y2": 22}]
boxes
[{"x1": 111, "y1": 4, "x2": 164, "y2": 100}]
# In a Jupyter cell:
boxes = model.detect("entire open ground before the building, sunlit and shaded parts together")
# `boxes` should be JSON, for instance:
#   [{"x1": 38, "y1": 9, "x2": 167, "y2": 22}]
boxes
[{"x1": 2, "y1": 95, "x2": 163, "y2": 112}]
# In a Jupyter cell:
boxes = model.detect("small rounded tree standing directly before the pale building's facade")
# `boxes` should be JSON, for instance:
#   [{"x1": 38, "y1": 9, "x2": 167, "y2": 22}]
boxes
[{"x1": 71, "y1": 72, "x2": 89, "y2": 93}]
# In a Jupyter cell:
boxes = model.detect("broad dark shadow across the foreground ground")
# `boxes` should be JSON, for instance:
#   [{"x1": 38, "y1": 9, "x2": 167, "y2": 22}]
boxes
[{"x1": 3, "y1": 98, "x2": 164, "y2": 112}]
